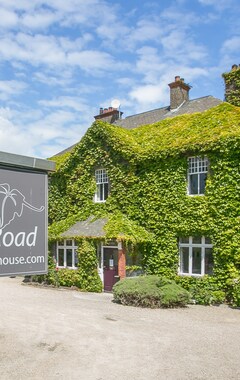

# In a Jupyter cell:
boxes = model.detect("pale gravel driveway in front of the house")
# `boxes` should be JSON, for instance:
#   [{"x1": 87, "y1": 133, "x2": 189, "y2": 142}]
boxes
[{"x1": 0, "y1": 277, "x2": 240, "y2": 380}]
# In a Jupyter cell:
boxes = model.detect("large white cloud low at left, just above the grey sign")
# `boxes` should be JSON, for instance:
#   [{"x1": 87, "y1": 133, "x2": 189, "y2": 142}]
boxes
[{"x1": 0, "y1": 109, "x2": 87, "y2": 158}]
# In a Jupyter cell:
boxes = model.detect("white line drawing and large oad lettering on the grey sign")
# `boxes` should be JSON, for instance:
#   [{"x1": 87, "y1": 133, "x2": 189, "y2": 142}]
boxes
[{"x1": 0, "y1": 183, "x2": 45, "y2": 247}]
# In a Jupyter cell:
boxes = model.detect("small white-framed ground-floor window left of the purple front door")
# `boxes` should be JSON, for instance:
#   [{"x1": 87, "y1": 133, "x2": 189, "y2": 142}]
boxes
[{"x1": 56, "y1": 239, "x2": 78, "y2": 269}]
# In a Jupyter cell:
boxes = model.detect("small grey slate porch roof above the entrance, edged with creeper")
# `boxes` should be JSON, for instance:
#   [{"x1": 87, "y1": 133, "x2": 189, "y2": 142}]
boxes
[{"x1": 61, "y1": 216, "x2": 108, "y2": 238}]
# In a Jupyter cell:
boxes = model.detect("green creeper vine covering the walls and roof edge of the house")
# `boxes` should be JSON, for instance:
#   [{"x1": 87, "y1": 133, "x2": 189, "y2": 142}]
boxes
[{"x1": 49, "y1": 103, "x2": 240, "y2": 302}]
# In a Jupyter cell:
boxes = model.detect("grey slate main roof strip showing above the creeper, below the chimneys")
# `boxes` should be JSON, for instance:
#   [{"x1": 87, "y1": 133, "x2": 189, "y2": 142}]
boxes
[{"x1": 114, "y1": 96, "x2": 222, "y2": 129}]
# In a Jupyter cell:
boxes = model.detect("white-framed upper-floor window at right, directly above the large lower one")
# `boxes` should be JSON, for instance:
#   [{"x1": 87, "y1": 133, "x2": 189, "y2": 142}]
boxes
[{"x1": 188, "y1": 157, "x2": 209, "y2": 195}]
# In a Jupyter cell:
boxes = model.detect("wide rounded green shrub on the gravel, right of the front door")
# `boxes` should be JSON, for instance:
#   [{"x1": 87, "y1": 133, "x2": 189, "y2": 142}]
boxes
[{"x1": 113, "y1": 275, "x2": 190, "y2": 308}]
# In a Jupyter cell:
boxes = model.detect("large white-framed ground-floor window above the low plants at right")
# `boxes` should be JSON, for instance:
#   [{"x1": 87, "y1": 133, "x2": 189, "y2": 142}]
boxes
[{"x1": 179, "y1": 236, "x2": 213, "y2": 276}]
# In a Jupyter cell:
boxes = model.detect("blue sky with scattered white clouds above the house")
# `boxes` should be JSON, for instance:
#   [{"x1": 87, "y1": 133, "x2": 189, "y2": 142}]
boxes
[{"x1": 0, "y1": 0, "x2": 240, "y2": 158}]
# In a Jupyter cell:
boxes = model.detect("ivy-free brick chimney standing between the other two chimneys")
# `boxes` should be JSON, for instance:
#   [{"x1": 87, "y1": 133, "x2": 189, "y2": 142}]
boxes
[{"x1": 169, "y1": 76, "x2": 191, "y2": 110}]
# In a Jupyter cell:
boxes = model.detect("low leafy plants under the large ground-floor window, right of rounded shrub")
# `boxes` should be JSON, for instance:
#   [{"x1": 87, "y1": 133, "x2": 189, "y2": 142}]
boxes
[{"x1": 176, "y1": 276, "x2": 226, "y2": 305}]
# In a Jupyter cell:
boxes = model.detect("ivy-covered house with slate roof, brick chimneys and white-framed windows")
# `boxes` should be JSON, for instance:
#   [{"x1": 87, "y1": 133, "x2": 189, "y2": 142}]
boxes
[{"x1": 49, "y1": 68, "x2": 240, "y2": 290}]
